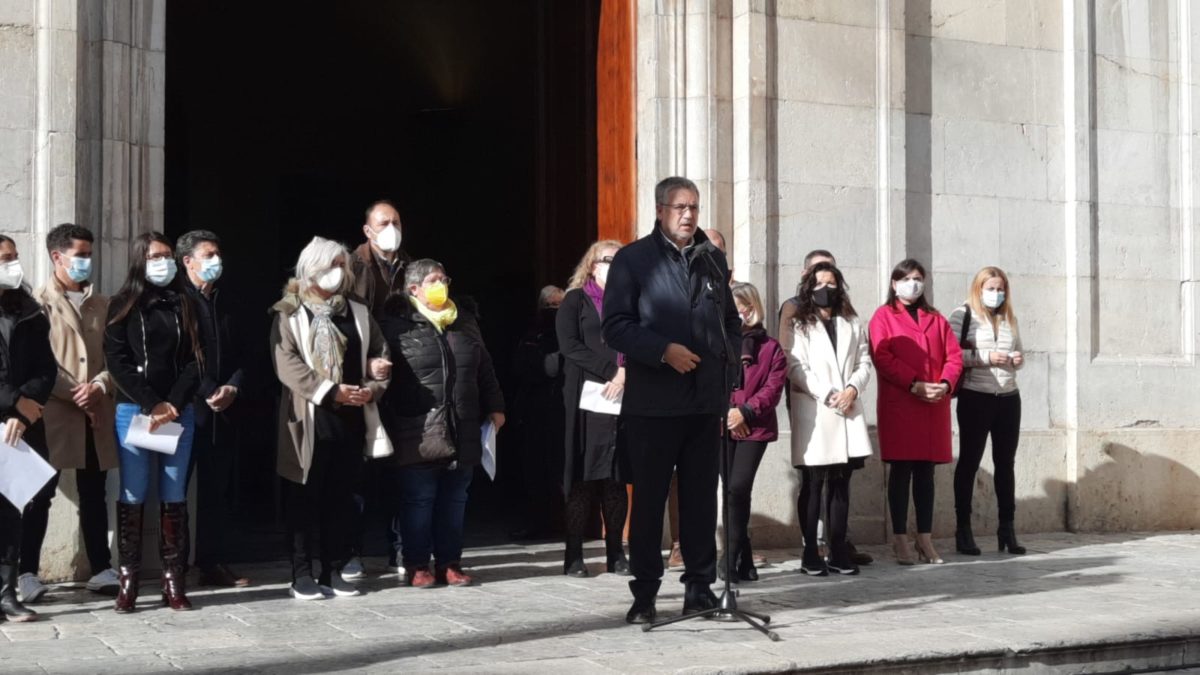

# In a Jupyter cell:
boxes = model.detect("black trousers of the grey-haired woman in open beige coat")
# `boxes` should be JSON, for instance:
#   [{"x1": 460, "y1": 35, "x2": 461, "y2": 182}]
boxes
[{"x1": 284, "y1": 441, "x2": 362, "y2": 584}]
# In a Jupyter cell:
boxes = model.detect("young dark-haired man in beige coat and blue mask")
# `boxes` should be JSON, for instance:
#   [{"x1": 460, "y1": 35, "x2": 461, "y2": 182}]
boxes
[{"x1": 17, "y1": 223, "x2": 118, "y2": 602}]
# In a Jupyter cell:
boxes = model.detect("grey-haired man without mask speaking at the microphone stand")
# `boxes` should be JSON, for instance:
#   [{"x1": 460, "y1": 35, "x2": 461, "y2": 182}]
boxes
[{"x1": 604, "y1": 172, "x2": 742, "y2": 623}]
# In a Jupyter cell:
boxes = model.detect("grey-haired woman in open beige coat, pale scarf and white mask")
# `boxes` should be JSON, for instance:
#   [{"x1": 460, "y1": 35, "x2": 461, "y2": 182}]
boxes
[{"x1": 270, "y1": 237, "x2": 392, "y2": 601}]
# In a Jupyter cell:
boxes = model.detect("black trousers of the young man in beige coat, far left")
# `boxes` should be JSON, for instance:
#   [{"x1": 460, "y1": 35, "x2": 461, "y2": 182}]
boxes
[{"x1": 19, "y1": 426, "x2": 113, "y2": 575}]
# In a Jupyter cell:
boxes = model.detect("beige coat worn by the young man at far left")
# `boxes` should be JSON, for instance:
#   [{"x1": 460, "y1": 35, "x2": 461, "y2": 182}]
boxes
[{"x1": 34, "y1": 279, "x2": 116, "y2": 471}]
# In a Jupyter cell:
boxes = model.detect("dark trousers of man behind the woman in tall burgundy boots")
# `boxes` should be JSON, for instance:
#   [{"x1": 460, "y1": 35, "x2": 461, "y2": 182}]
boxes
[{"x1": 192, "y1": 415, "x2": 236, "y2": 568}]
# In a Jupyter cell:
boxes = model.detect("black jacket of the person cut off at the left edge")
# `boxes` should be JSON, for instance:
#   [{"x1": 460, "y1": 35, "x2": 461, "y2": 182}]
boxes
[{"x1": 0, "y1": 289, "x2": 59, "y2": 432}]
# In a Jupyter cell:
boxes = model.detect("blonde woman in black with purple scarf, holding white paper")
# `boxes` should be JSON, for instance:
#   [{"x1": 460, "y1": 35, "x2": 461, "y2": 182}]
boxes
[{"x1": 556, "y1": 240, "x2": 629, "y2": 577}]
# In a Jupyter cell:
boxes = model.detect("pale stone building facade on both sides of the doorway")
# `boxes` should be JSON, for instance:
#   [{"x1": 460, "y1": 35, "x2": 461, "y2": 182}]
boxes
[{"x1": 0, "y1": 0, "x2": 1200, "y2": 578}]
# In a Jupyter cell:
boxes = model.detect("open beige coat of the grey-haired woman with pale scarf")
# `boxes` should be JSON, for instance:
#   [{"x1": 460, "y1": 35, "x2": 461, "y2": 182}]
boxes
[{"x1": 271, "y1": 282, "x2": 392, "y2": 484}]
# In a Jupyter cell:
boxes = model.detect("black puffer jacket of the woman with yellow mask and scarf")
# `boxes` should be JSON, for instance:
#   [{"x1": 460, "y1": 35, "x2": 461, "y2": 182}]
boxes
[{"x1": 379, "y1": 302, "x2": 504, "y2": 466}]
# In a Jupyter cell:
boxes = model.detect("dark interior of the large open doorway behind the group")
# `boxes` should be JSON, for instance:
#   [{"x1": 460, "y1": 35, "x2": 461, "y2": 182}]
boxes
[{"x1": 166, "y1": 0, "x2": 600, "y2": 557}]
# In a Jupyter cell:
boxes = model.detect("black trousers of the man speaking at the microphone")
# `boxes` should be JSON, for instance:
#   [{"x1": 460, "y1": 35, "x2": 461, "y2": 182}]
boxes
[{"x1": 624, "y1": 414, "x2": 721, "y2": 599}]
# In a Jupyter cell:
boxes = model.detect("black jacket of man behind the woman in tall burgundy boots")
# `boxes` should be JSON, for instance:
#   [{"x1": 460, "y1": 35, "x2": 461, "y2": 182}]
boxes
[{"x1": 184, "y1": 280, "x2": 245, "y2": 425}]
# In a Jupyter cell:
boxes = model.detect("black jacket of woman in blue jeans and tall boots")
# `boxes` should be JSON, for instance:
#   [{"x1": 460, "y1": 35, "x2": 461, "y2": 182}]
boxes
[{"x1": 104, "y1": 287, "x2": 200, "y2": 414}]
